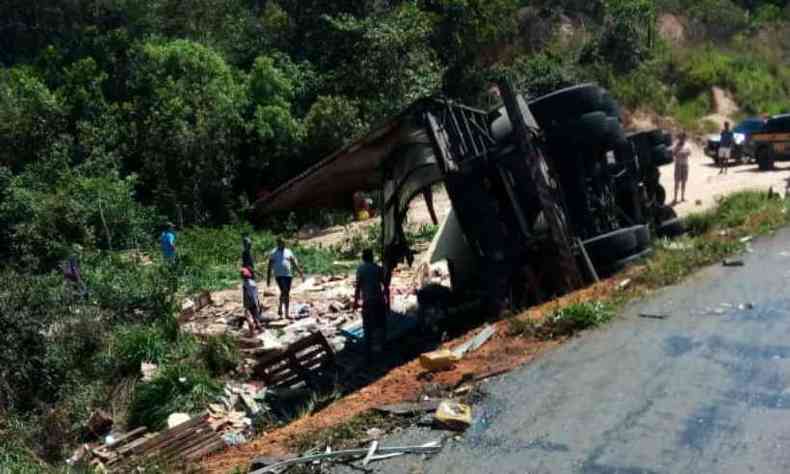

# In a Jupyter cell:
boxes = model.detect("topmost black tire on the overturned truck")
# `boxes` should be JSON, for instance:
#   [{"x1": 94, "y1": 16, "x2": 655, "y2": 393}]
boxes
[{"x1": 529, "y1": 84, "x2": 604, "y2": 129}]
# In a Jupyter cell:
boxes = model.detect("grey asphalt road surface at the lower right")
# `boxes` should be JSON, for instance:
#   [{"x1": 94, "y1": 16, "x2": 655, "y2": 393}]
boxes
[{"x1": 337, "y1": 231, "x2": 790, "y2": 474}]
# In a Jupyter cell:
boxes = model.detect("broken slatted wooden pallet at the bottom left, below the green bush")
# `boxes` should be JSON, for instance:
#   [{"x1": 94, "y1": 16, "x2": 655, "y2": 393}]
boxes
[{"x1": 93, "y1": 413, "x2": 225, "y2": 472}]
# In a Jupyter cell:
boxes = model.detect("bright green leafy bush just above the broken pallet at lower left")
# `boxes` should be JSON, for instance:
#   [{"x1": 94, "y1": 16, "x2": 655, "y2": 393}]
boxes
[{"x1": 129, "y1": 364, "x2": 222, "y2": 430}]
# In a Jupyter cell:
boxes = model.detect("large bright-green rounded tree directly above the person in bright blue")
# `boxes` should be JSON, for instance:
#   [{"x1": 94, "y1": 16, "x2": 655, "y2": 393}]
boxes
[{"x1": 129, "y1": 40, "x2": 244, "y2": 223}]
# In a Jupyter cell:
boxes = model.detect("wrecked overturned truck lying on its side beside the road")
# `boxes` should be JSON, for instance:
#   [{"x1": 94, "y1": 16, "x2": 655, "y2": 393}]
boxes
[{"x1": 256, "y1": 82, "x2": 680, "y2": 313}]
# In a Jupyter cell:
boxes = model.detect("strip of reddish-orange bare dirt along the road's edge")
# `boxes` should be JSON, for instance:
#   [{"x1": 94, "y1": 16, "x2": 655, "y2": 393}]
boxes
[{"x1": 203, "y1": 269, "x2": 636, "y2": 473}]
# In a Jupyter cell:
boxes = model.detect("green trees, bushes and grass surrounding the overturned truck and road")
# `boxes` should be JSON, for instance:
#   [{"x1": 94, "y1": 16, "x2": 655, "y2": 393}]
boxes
[{"x1": 0, "y1": 0, "x2": 790, "y2": 472}]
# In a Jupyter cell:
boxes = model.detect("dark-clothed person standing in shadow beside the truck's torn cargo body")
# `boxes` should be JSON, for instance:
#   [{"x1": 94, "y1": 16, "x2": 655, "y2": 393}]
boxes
[{"x1": 354, "y1": 249, "x2": 387, "y2": 362}]
